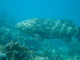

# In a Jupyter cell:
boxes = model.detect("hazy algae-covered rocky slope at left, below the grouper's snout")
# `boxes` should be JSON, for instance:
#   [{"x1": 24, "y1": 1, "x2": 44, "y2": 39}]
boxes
[{"x1": 0, "y1": 26, "x2": 25, "y2": 45}]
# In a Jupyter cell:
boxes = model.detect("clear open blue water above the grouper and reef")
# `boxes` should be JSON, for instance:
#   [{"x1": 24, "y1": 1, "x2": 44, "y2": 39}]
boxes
[{"x1": 0, "y1": 0, "x2": 80, "y2": 25}]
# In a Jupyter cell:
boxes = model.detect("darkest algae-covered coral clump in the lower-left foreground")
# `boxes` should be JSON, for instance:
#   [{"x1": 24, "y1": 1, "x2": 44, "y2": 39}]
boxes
[{"x1": 6, "y1": 43, "x2": 29, "y2": 60}]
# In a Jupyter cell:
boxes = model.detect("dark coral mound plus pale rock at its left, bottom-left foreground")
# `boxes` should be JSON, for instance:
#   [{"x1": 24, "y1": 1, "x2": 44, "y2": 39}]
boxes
[{"x1": 0, "y1": 42, "x2": 33, "y2": 60}]
